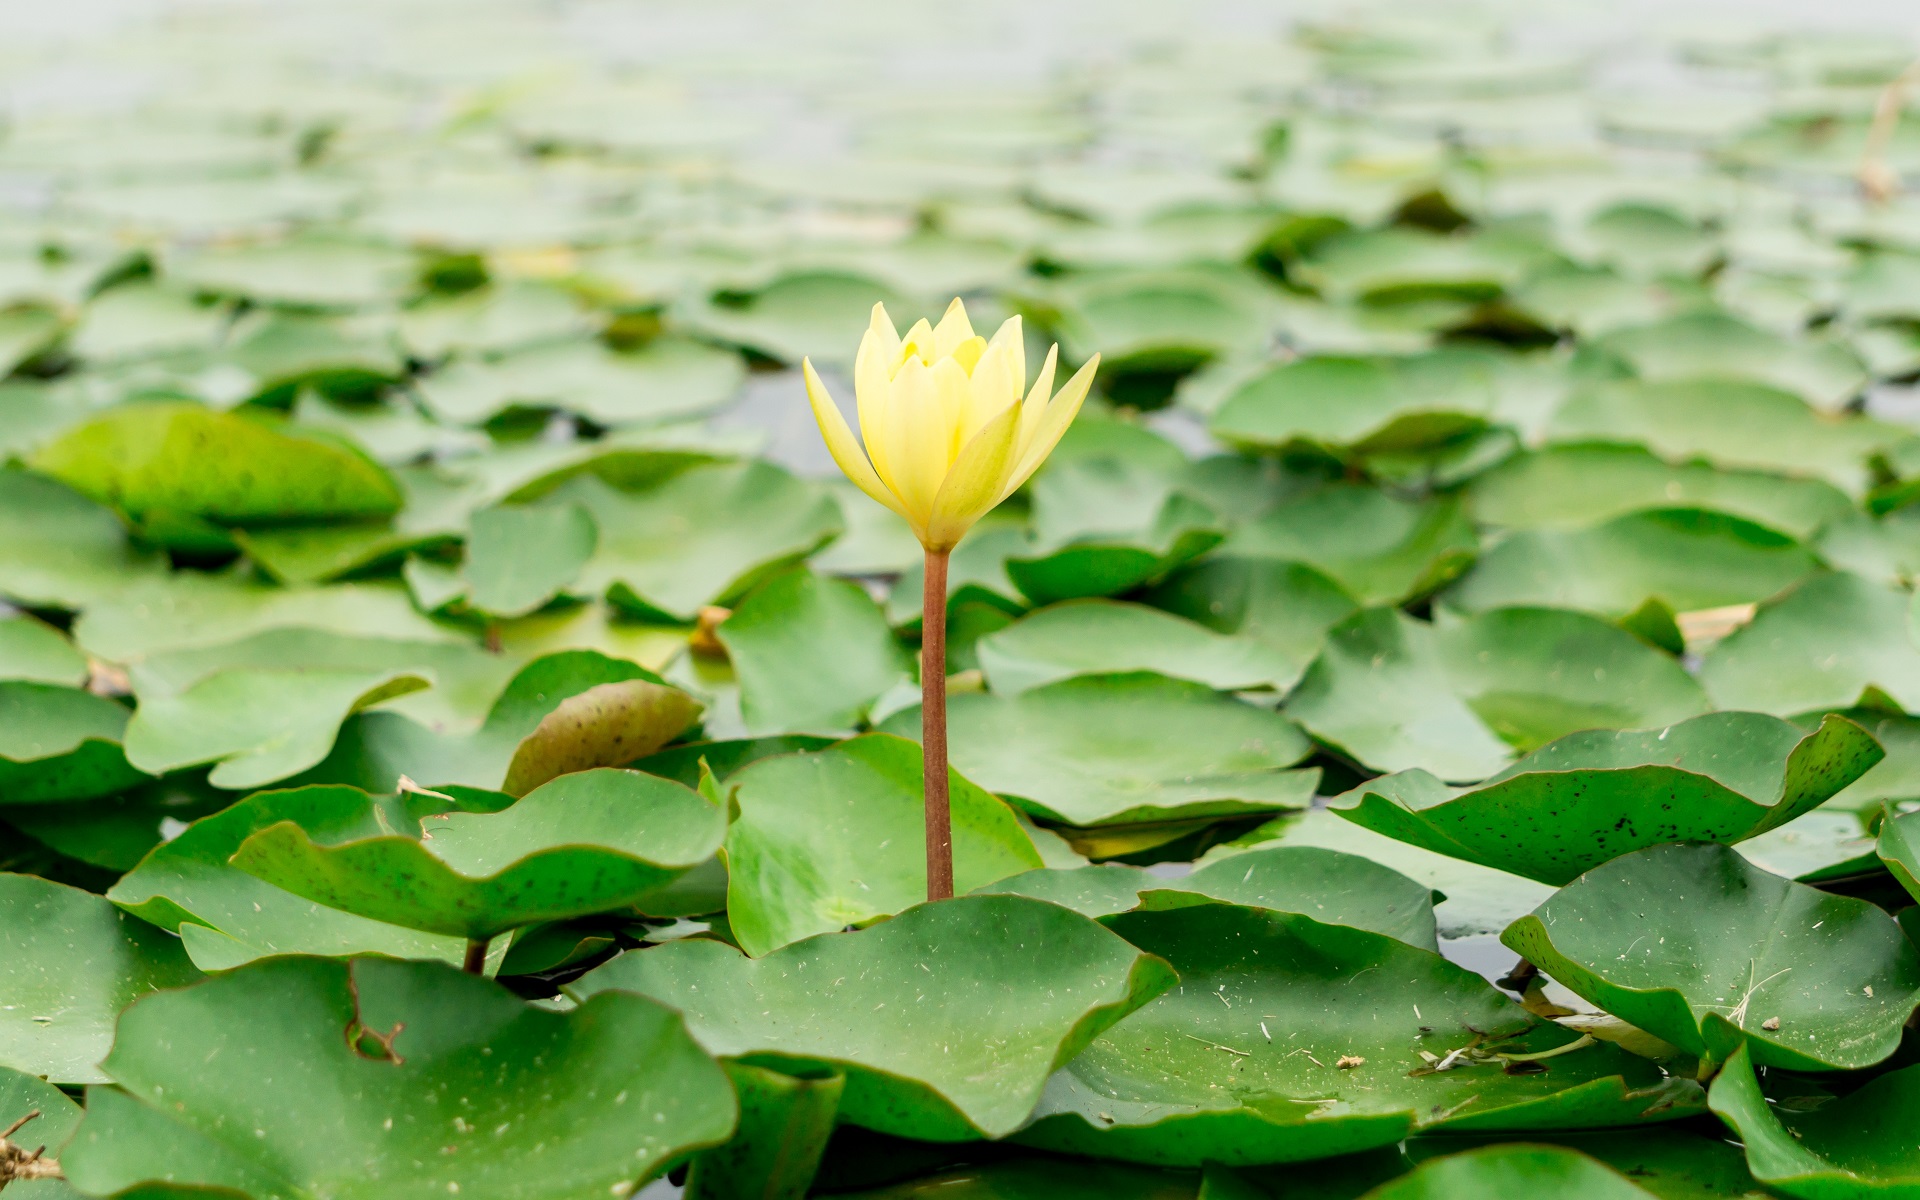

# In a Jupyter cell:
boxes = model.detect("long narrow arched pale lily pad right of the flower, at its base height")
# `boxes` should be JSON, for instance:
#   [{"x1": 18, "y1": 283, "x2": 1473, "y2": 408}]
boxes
[{"x1": 1469, "y1": 444, "x2": 1853, "y2": 541}]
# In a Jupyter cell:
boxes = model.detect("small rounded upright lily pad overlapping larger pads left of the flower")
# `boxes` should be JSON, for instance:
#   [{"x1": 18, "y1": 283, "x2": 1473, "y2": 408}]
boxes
[{"x1": 463, "y1": 505, "x2": 599, "y2": 616}]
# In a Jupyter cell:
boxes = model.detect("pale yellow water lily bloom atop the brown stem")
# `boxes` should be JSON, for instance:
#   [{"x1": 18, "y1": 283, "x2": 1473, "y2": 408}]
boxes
[{"x1": 801, "y1": 300, "x2": 1100, "y2": 553}]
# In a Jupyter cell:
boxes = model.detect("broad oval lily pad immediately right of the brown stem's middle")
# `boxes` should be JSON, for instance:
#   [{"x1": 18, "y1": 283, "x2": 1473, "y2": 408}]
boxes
[{"x1": 879, "y1": 672, "x2": 1319, "y2": 826}]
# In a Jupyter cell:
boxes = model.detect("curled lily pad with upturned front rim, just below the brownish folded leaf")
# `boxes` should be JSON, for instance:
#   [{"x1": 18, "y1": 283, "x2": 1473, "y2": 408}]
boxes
[{"x1": 232, "y1": 768, "x2": 726, "y2": 941}]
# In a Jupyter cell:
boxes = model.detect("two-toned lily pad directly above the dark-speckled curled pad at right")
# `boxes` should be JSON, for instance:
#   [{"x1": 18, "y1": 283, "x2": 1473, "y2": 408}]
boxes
[{"x1": 1286, "y1": 609, "x2": 1707, "y2": 780}]
